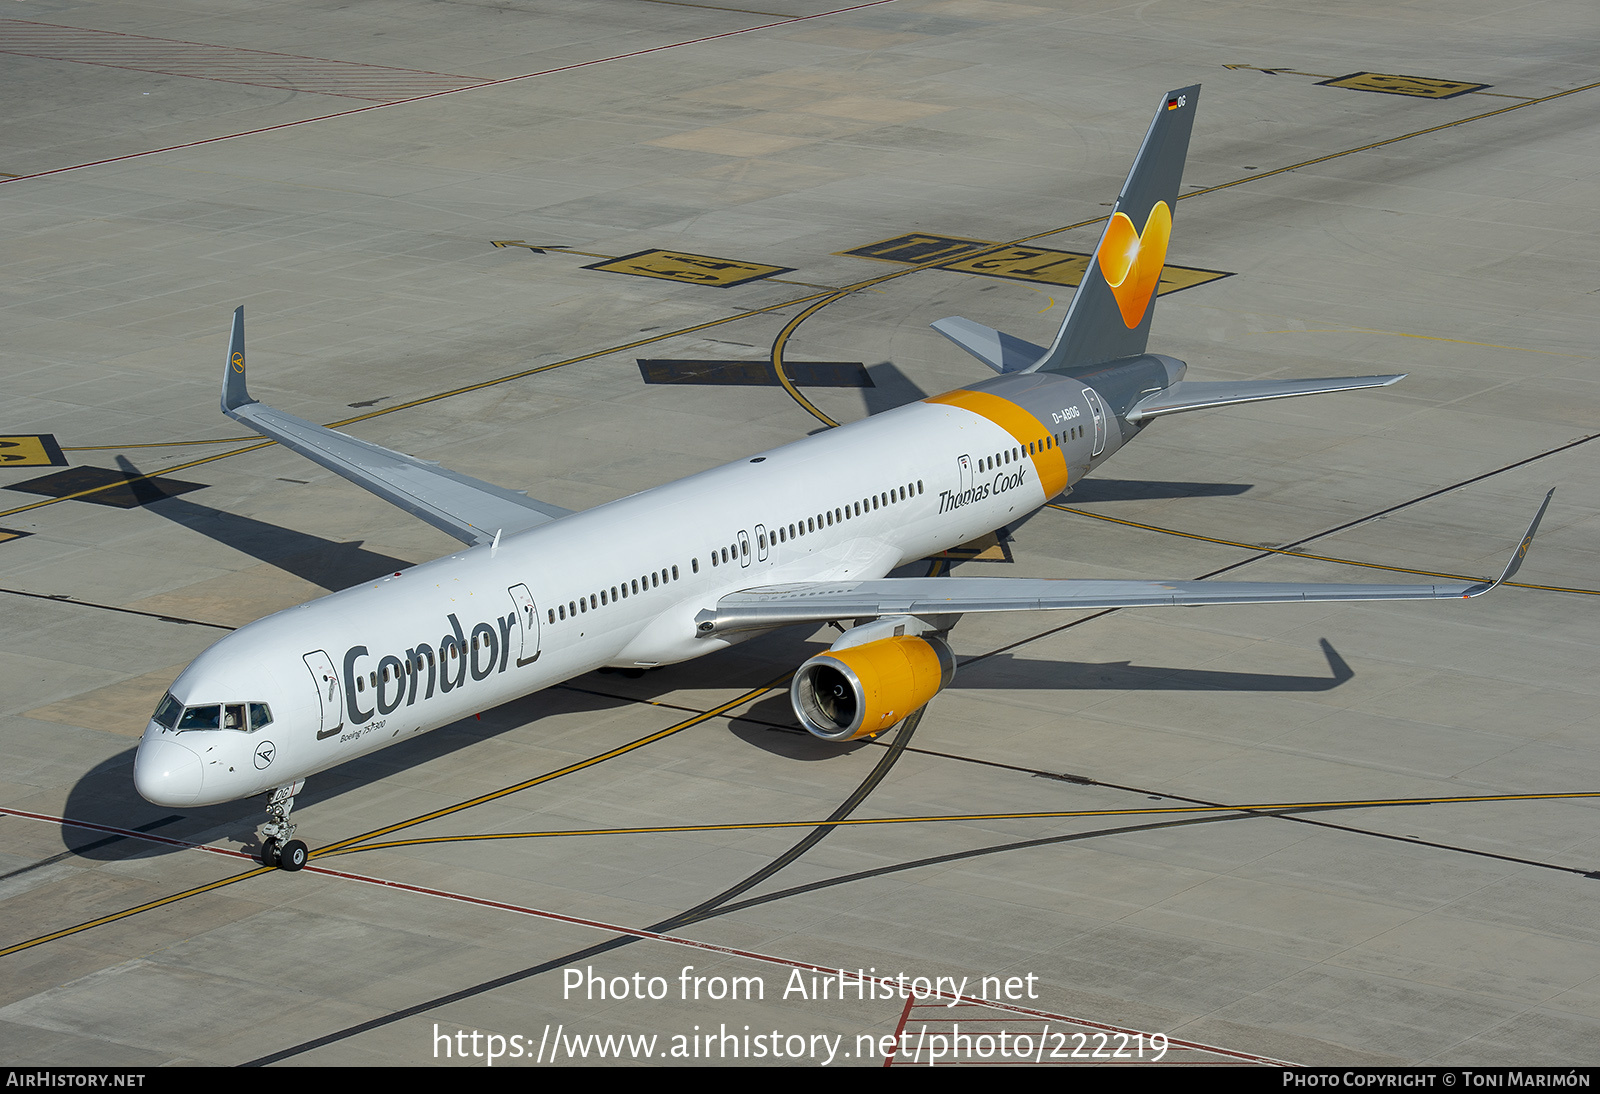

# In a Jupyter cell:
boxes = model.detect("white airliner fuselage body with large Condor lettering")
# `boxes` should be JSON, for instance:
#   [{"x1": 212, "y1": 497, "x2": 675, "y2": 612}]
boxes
[{"x1": 134, "y1": 379, "x2": 1120, "y2": 806}]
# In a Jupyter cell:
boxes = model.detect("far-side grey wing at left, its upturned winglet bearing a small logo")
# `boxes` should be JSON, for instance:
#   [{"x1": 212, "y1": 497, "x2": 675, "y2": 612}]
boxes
[{"x1": 222, "y1": 307, "x2": 571, "y2": 544}]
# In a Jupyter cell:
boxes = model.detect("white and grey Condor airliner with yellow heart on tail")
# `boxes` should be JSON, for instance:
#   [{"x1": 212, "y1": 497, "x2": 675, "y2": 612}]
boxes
[{"x1": 134, "y1": 86, "x2": 1550, "y2": 870}]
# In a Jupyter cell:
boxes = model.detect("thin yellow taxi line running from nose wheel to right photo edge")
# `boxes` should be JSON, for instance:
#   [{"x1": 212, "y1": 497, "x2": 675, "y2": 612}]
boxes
[{"x1": 321, "y1": 790, "x2": 1600, "y2": 854}]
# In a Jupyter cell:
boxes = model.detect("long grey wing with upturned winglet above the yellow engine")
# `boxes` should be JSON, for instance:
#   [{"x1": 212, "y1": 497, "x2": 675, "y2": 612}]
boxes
[{"x1": 694, "y1": 489, "x2": 1555, "y2": 637}]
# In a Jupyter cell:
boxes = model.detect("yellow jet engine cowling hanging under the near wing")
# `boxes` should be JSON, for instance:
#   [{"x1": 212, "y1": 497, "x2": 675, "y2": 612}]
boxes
[{"x1": 789, "y1": 635, "x2": 955, "y2": 741}]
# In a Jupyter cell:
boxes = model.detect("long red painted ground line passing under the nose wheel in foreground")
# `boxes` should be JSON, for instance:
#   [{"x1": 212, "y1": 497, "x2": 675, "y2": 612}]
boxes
[{"x1": 0, "y1": 806, "x2": 1294, "y2": 1067}]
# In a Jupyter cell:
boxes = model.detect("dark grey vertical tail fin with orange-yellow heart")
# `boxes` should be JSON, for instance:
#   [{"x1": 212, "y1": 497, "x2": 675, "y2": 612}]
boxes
[{"x1": 1026, "y1": 83, "x2": 1200, "y2": 371}]
